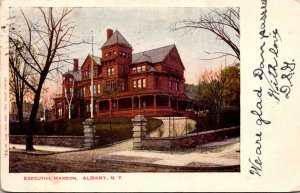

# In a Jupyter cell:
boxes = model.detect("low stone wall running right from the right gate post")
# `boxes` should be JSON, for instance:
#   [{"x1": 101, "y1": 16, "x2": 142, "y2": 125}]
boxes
[{"x1": 141, "y1": 127, "x2": 240, "y2": 150}]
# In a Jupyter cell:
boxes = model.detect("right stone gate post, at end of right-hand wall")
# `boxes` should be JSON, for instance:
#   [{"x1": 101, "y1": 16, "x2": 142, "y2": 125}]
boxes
[{"x1": 131, "y1": 115, "x2": 147, "y2": 150}]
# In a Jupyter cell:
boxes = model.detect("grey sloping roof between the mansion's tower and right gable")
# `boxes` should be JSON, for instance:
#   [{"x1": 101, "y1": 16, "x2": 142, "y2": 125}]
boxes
[{"x1": 132, "y1": 44, "x2": 175, "y2": 64}]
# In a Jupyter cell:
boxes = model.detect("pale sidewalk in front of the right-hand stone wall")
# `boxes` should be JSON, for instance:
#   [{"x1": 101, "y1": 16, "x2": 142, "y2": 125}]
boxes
[{"x1": 95, "y1": 138, "x2": 240, "y2": 167}]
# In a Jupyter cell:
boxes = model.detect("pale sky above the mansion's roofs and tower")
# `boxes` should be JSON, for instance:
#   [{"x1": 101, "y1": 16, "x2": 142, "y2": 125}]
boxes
[{"x1": 10, "y1": 7, "x2": 239, "y2": 84}]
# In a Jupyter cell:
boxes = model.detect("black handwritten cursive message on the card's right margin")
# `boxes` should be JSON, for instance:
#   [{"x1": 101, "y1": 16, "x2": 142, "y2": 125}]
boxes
[{"x1": 249, "y1": 0, "x2": 296, "y2": 176}]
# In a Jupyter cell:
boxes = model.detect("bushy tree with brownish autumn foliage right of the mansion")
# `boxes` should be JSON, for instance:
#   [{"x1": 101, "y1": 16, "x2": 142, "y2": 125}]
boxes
[{"x1": 198, "y1": 64, "x2": 240, "y2": 125}]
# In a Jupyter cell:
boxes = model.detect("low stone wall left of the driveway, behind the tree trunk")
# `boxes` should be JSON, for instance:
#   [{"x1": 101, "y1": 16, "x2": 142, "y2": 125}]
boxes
[{"x1": 9, "y1": 135, "x2": 99, "y2": 148}]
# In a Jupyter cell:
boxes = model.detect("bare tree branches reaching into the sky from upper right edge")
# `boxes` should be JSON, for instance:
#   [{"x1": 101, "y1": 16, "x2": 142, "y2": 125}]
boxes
[{"x1": 171, "y1": 8, "x2": 240, "y2": 60}]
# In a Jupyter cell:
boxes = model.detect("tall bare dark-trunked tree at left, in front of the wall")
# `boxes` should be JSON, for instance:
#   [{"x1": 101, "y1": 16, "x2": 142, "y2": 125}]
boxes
[{"x1": 9, "y1": 8, "x2": 79, "y2": 150}]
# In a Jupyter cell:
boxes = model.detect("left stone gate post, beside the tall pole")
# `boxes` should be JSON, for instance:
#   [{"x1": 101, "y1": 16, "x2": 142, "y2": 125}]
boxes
[{"x1": 83, "y1": 119, "x2": 96, "y2": 149}]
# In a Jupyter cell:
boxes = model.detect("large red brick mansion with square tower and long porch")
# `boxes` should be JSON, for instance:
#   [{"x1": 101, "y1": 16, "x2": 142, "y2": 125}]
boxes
[{"x1": 52, "y1": 29, "x2": 188, "y2": 119}]
